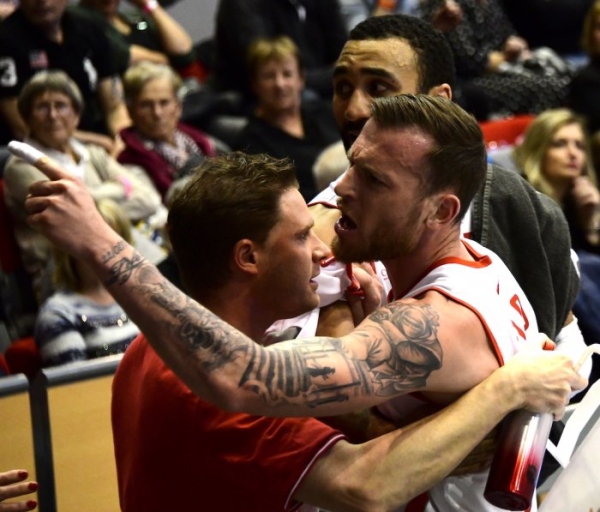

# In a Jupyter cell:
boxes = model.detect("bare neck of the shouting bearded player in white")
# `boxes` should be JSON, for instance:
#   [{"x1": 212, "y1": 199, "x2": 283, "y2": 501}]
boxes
[{"x1": 383, "y1": 226, "x2": 473, "y2": 298}]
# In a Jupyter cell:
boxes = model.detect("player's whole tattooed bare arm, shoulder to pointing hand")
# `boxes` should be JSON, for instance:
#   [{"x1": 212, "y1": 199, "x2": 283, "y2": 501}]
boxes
[{"x1": 26, "y1": 158, "x2": 493, "y2": 416}]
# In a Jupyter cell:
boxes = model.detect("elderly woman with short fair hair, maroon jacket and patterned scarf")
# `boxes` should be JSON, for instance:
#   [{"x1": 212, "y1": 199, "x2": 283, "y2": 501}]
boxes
[{"x1": 117, "y1": 62, "x2": 215, "y2": 198}]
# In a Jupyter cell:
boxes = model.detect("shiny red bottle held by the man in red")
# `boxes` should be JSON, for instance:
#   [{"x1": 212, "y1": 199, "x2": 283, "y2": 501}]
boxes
[{"x1": 484, "y1": 410, "x2": 552, "y2": 510}]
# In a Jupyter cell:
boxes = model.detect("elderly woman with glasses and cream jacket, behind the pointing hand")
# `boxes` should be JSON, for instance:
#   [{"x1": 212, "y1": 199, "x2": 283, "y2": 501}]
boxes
[{"x1": 4, "y1": 71, "x2": 162, "y2": 300}]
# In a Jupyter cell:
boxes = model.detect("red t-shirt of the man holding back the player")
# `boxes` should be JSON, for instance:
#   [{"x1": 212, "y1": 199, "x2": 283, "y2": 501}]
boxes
[{"x1": 112, "y1": 335, "x2": 343, "y2": 512}]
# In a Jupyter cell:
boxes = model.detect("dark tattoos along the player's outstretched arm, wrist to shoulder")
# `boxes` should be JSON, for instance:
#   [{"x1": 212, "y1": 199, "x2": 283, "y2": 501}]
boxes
[{"x1": 105, "y1": 240, "x2": 443, "y2": 408}]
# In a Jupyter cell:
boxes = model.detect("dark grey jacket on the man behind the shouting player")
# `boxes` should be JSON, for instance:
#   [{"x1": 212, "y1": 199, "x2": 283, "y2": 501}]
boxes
[{"x1": 471, "y1": 166, "x2": 579, "y2": 339}]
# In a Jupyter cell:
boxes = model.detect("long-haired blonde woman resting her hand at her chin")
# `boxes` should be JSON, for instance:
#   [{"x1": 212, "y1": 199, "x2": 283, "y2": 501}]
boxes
[{"x1": 513, "y1": 109, "x2": 600, "y2": 383}]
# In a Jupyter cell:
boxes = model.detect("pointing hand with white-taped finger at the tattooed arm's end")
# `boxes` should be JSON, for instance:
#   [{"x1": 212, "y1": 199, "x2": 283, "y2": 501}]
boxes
[{"x1": 8, "y1": 141, "x2": 118, "y2": 258}]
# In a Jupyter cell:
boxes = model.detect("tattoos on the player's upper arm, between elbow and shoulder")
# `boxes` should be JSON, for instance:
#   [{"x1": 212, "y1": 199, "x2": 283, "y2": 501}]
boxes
[{"x1": 240, "y1": 302, "x2": 442, "y2": 407}]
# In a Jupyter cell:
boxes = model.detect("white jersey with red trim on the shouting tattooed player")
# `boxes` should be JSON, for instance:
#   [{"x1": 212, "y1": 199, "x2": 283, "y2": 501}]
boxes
[{"x1": 379, "y1": 240, "x2": 538, "y2": 512}]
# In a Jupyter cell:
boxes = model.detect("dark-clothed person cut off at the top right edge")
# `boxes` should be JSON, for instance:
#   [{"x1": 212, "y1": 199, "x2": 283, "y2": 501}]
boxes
[{"x1": 569, "y1": 1, "x2": 600, "y2": 133}]
